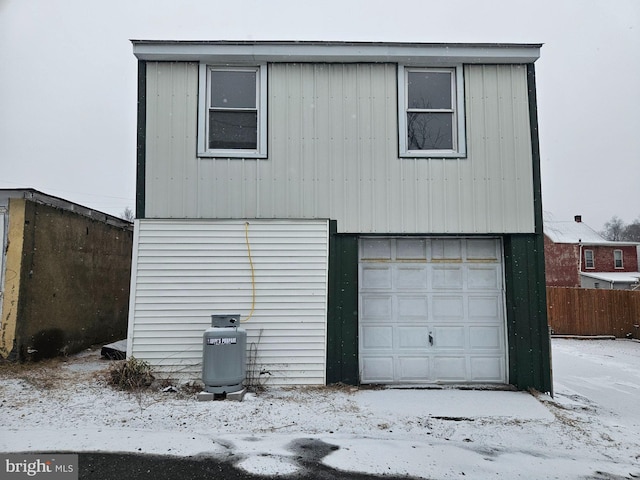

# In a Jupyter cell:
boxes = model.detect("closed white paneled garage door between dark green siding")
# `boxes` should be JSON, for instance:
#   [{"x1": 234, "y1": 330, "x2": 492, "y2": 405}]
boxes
[{"x1": 359, "y1": 237, "x2": 507, "y2": 384}]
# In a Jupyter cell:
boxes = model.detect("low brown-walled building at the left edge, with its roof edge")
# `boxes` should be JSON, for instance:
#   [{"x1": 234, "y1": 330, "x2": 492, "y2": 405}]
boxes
[{"x1": 0, "y1": 189, "x2": 133, "y2": 361}]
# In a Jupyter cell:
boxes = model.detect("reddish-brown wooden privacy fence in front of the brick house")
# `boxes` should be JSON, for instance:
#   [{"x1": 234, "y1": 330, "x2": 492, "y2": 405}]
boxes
[{"x1": 547, "y1": 287, "x2": 640, "y2": 338}]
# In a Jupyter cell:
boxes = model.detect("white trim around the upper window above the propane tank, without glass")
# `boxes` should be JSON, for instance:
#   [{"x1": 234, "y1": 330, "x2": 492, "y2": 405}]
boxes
[{"x1": 198, "y1": 63, "x2": 267, "y2": 158}]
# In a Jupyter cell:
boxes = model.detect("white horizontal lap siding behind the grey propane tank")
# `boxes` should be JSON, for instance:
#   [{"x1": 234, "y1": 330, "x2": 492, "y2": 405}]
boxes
[{"x1": 129, "y1": 220, "x2": 329, "y2": 385}]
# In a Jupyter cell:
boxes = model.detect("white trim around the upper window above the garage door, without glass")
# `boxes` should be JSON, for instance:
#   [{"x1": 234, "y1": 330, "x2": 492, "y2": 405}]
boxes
[{"x1": 398, "y1": 64, "x2": 467, "y2": 158}]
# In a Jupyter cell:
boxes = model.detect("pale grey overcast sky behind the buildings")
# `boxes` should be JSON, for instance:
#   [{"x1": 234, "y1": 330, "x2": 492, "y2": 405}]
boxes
[{"x1": 0, "y1": 0, "x2": 640, "y2": 230}]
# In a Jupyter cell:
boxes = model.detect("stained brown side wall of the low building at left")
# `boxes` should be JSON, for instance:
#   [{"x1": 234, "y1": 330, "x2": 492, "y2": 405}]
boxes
[{"x1": 7, "y1": 201, "x2": 133, "y2": 360}]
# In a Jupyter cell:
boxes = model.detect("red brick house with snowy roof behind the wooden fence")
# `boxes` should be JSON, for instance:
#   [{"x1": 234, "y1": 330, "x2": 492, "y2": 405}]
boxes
[{"x1": 544, "y1": 215, "x2": 640, "y2": 290}]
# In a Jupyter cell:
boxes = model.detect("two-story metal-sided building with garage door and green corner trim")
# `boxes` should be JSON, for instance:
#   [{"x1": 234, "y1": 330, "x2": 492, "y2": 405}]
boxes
[{"x1": 128, "y1": 40, "x2": 551, "y2": 391}]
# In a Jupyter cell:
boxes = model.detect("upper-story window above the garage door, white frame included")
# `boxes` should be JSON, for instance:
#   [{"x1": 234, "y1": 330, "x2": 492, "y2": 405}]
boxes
[{"x1": 398, "y1": 66, "x2": 466, "y2": 157}]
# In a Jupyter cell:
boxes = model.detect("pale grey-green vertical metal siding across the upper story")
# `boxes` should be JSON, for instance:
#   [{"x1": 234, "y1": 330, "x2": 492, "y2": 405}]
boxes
[{"x1": 146, "y1": 63, "x2": 534, "y2": 234}]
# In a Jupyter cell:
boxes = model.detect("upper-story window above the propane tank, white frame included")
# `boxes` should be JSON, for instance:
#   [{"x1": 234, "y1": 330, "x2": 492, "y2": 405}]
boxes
[{"x1": 198, "y1": 65, "x2": 267, "y2": 158}]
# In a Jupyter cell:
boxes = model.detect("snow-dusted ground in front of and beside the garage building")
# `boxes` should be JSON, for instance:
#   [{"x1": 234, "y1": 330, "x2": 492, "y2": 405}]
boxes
[{"x1": 0, "y1": 339, "x2": 640, "y2": 479}]
